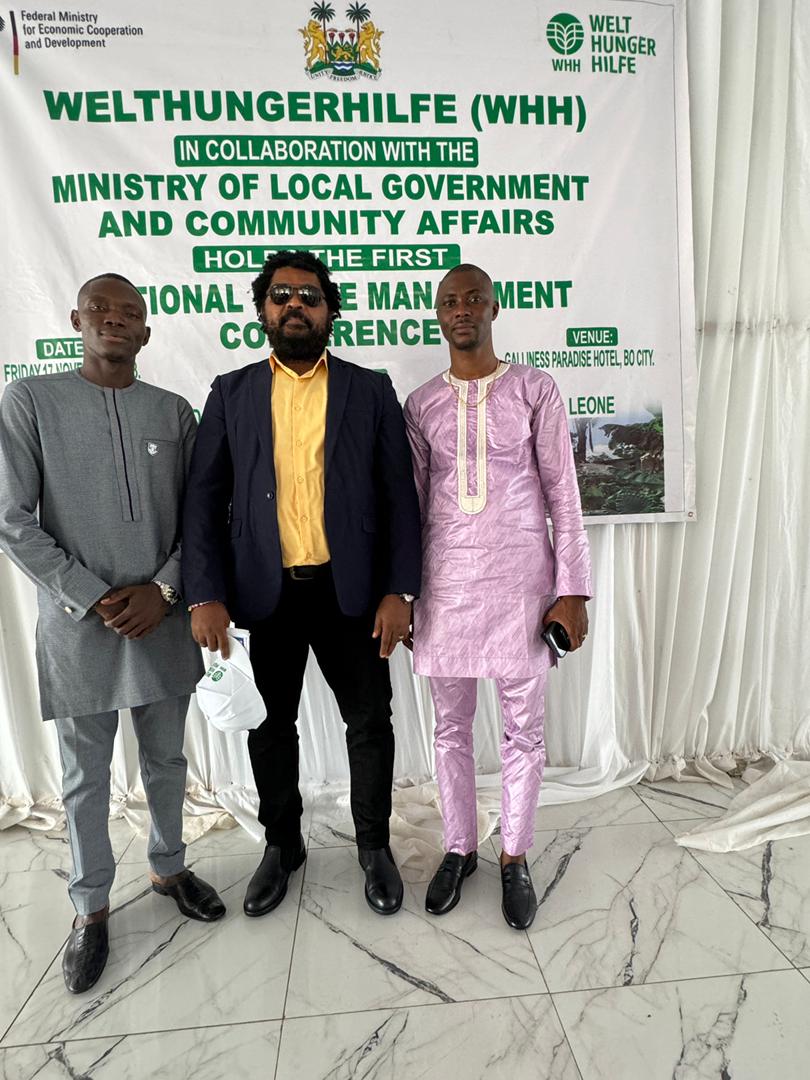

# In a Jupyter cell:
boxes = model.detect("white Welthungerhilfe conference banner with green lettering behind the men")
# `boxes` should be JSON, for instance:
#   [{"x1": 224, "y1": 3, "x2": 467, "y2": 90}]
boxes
[{"x1": 0, "y1": 0, "x2": 696, "y2": 522}]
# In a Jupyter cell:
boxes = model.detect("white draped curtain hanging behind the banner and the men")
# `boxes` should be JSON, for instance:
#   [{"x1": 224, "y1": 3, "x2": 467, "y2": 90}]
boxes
[{"x1": 0, "y1": 0, "x2": 810, "y2": 826}]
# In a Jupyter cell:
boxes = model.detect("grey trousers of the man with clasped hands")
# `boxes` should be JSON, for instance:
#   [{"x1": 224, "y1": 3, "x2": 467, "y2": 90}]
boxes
[{"x1": 55, "y1": 694, "x2": 189, "y2": 915}]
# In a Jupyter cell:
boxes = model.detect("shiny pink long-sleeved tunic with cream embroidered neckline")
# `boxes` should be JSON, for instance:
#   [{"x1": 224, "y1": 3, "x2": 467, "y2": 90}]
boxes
[{"x1": 405, "y1": 363, "x2": 591, "y2": 678}]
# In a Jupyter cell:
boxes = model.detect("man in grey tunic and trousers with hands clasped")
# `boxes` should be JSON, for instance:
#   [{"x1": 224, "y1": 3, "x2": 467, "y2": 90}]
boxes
[{"x1": 0, "y1": 274, "x2": 225, "y2": 994}]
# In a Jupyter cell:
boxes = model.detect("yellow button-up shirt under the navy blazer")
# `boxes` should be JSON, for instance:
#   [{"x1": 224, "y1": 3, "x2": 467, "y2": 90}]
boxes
[{"x1": 270, "y1": 350, "x2": 329, "y2": 566}]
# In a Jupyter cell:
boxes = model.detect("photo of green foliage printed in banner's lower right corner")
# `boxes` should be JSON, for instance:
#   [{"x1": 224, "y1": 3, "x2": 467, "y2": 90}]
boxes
[{"x1": 569, "y1": 404, "x2": 664, "y2": 515}]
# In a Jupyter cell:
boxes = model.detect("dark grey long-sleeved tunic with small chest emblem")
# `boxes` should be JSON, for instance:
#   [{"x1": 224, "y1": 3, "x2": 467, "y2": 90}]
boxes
[{"x1": 0, "y1": 372, "x2": 202, "y2": 719}]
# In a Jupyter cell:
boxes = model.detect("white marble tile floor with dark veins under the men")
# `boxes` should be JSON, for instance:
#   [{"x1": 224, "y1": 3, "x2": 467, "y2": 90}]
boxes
[{"x1": 0, "y1": 781, "x2": 810, "y2": 1080}]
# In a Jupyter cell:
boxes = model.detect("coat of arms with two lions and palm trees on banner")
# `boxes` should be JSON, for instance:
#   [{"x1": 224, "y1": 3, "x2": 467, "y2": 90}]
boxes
[{"x1": 298, "y1": 3, "x2": 383, "y2": 79}]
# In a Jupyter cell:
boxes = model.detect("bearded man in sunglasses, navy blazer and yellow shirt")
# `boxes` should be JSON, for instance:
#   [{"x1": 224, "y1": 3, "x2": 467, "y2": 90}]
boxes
[{"x1": 183, "y1": 252, "x2": 421, "y2": 916}]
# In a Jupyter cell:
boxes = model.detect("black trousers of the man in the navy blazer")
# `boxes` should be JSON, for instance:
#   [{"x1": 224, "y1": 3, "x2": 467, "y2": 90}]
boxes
[{"x1": 247, "y1": 565, "x2": 394, "y2": 853}]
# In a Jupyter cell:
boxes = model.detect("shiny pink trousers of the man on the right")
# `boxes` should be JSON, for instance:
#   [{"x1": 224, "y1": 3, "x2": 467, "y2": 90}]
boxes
[{"x1": 430, "y1": 672, "x2": 545, "y2": 855}]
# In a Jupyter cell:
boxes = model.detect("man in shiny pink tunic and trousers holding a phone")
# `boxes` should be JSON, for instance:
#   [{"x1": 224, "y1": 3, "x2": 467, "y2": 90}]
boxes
[{"x1": 405, "y1": 265, "x2": 591, "y2": 930}]
